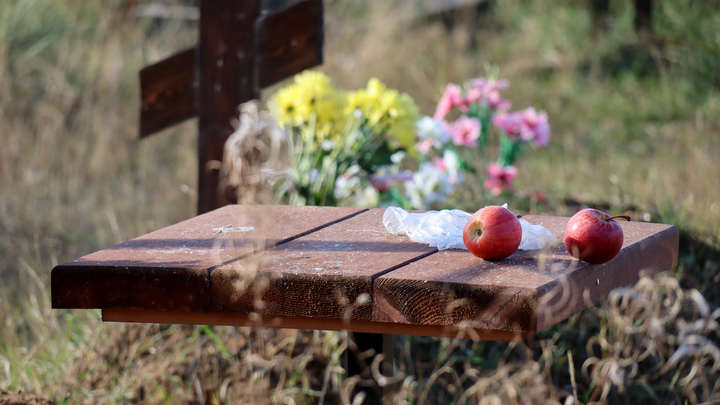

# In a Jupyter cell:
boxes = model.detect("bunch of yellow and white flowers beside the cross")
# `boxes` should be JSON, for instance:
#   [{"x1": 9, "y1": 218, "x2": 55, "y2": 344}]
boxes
[{"x1": 270, "y1": 71, "x2": 419, "y2": 206}]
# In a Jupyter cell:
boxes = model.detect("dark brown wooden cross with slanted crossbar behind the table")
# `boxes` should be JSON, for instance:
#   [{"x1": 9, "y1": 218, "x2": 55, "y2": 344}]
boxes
[{"x1": 140, "y1": 0, "x2": 323, "y2": 214}]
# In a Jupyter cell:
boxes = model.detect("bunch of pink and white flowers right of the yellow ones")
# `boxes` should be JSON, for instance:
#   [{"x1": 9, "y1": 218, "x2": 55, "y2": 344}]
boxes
[{"x1": 416, "y1": 78, "x2": 550, "y2": 196}]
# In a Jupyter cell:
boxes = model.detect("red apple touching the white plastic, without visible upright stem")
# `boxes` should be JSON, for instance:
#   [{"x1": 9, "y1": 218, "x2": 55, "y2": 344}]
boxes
[{"x1": 463, "y1": 205, "x2": 522, "y2": 260}]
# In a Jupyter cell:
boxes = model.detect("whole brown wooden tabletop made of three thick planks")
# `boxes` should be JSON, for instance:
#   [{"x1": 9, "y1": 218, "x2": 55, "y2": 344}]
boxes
[{"x1": 52, "y1": 206, "x2": 678, "y2": 340}]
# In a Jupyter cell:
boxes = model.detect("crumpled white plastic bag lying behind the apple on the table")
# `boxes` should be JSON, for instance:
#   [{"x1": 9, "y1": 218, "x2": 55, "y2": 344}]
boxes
[{"x1": 383, "y1": 204, "x2": 557, "y2": 250}]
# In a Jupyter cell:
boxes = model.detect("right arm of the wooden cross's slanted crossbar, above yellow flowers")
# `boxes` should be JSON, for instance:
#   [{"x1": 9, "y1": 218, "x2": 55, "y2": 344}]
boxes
[{"x1": 256, "y1": 0, "x2": 324, "y2": 88}]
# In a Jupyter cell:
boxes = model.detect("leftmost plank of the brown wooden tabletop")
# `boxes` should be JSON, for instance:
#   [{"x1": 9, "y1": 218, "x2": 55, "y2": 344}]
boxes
[{"x1": 51, "y1": 205, "x2": 363, "y2": 311}]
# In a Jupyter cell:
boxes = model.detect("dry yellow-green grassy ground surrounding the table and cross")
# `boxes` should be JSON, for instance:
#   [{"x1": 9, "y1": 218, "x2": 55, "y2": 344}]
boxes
[{"x1": 0, "y1": 0, "x2": 720, "y2": 403}]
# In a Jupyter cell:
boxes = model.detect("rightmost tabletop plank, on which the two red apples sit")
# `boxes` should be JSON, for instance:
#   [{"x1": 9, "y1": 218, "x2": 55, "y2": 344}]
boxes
[{"x1": 372, "y1": 216, "x2": 679, "y2": 335}]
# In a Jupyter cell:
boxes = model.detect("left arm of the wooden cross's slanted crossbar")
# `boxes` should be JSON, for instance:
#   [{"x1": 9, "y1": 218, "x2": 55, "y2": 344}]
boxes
[{"x1": 140, "y1": 47, "x2": 197, "y2": 138}]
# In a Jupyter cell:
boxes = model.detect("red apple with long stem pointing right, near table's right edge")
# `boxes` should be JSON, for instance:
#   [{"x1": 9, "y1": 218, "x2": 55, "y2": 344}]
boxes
[{"x1": 565, "y1": 208, "x2": 630, "y2": 264}]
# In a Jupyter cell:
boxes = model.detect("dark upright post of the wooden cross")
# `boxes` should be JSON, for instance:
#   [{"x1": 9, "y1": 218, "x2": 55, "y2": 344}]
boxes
[{"x1": 196, "y1": 0, "x2": 260, "y2": 213}]
